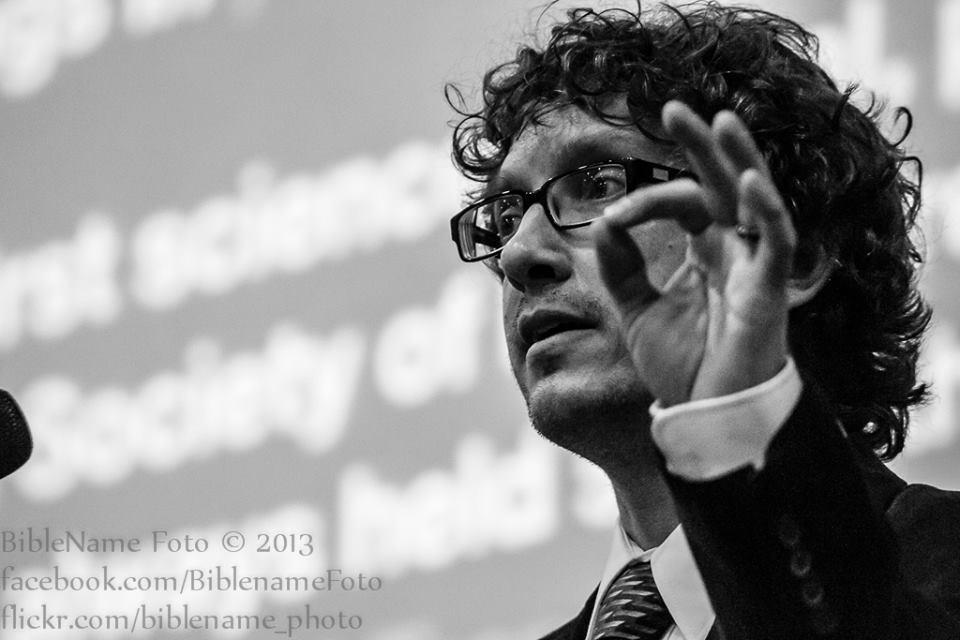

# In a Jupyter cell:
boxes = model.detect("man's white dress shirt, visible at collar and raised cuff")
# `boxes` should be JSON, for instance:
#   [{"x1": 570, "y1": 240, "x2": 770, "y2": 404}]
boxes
[{"x1": 587, "y1": 358, "x2": 803, "y2": 640}]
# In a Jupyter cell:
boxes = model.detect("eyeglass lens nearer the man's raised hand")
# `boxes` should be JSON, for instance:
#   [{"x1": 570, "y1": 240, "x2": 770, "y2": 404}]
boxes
[{"x1": 547, "y1": 164, "x2": 627, "y2": 225}]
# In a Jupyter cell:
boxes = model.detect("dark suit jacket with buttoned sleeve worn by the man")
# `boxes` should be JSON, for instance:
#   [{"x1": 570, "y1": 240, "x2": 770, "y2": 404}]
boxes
[{"x1": 543, "y1": 384, "x2": 960, "y2": 640}]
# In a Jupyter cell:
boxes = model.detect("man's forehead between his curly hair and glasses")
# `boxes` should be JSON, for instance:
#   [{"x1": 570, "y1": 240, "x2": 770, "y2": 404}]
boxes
[{"x1": 491, "y1": 106, "x2": 676, "y2": 189}]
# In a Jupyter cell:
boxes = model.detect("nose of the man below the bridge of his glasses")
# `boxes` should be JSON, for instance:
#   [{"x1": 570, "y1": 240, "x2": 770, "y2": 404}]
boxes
[{"x1": 500, "y1": 204, "x2": 571, "y2": 292}]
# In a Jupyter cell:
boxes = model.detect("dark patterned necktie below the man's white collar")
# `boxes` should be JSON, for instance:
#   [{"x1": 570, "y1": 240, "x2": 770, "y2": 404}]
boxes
[{"x1": 593, "y1": 560, "x2": 673, "y2": 640}]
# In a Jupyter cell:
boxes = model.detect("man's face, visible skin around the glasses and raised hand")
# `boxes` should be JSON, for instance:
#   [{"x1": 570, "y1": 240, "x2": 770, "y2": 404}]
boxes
[{"x1": 496, "y1": 107, "x2": 687, "y2": 462}]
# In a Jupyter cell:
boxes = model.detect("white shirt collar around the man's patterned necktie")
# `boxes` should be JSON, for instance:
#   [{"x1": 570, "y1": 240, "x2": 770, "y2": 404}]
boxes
[{"x1": 588, "y1": 525, "x2": 714, "y2": 640}]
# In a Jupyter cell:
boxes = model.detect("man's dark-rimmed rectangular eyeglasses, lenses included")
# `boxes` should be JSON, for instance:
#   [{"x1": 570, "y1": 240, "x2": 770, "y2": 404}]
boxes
[{"x1": 450, "y1": 158, "x2": 690, "y2": 262}]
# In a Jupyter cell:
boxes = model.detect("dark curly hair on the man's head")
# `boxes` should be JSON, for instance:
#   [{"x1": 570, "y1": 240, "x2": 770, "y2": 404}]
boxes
[{"x1": 447, "y1": 0, "x2": 930, "y2": 460}]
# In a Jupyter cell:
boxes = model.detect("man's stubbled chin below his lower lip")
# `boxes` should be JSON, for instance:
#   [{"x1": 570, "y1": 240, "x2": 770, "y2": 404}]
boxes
[{"x1": 526, "y1": 372, "x2": 653, "y2": 468}]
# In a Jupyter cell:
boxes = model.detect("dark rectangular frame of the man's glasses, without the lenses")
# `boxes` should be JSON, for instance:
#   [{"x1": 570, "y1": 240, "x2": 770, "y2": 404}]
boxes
[{"x1": 450, "y1": 157, "x2": 693, "y2": 262}]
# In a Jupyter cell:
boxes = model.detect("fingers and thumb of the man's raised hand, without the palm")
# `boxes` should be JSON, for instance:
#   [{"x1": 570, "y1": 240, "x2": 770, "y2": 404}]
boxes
[{"x1": 594, "y1": 102, "x2": 796, "y2": 316}]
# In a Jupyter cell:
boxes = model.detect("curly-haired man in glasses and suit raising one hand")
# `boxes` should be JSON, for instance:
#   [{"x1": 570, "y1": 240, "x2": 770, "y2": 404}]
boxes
[{"x1": 451, "y1": 3, "x2": 960, "y2": 640}]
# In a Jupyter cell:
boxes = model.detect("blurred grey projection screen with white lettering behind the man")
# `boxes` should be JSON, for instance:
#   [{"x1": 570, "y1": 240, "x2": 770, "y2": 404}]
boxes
[{"x1": 0, "y1": 0, "x2": 960, "y2": 640}]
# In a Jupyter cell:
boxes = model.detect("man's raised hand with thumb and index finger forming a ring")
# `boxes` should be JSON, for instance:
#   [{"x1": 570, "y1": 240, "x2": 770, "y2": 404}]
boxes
[{"x1": 592, "y1": 102, "x2": 796, "y2": 406}]
